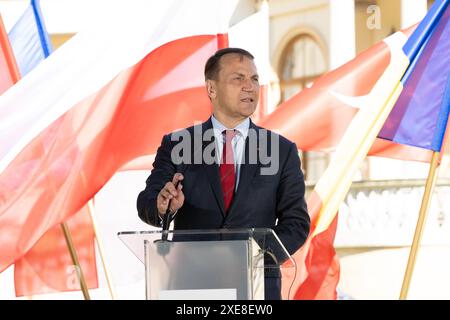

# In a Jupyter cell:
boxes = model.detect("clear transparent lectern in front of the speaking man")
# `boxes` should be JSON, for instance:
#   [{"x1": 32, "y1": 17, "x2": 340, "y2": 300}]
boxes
[{"x1": 118, "y1": 229, "x2": 294, "y2": 300}]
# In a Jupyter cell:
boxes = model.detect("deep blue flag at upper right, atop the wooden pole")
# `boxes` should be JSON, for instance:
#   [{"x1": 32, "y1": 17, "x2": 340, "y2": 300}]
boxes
[{"x1": 379, "y1": 0, "x2": 450, "y2": 151}]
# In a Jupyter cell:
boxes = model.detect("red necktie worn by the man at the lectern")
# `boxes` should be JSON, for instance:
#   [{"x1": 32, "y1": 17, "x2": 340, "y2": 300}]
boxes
[{"x1": 219, "y1": 130, "x2": 236, "y2": 212}]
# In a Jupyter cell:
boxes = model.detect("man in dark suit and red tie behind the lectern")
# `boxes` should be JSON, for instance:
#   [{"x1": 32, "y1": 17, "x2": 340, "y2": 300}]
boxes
[{"x1": 137, "y1": 48, "x2": 310, "y2": 299}]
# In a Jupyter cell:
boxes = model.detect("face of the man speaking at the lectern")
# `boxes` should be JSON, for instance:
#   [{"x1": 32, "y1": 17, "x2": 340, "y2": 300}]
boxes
[{"x1": 207, "y1": 53, "x2": 259, "y2": 120}]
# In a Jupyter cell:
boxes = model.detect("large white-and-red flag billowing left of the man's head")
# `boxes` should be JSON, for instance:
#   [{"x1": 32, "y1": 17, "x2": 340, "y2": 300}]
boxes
[{"x1": 0, "y1": 0, "x2": 237, "y2": 271}]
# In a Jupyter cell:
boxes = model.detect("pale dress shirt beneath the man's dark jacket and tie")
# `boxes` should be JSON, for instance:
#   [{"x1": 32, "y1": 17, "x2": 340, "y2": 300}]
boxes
[{"x1": 211, "y1": 115, "x2": 250, "y2": 191}]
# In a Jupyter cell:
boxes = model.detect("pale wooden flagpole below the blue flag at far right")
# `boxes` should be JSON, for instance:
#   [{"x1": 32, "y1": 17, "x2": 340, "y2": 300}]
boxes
[{"x1": 400, "y1": 152, "x2": 440, "y2": 300}]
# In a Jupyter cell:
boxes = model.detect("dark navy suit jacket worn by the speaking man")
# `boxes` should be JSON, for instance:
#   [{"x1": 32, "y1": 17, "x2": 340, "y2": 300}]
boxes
[{"x1": 137, "y1": 119, "x2": 310, "y2": 299}]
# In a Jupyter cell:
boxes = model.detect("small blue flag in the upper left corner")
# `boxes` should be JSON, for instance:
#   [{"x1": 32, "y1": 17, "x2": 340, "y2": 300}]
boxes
[{"x1": 8, "y1": 0, "x2": 52, "y2": 77}]
